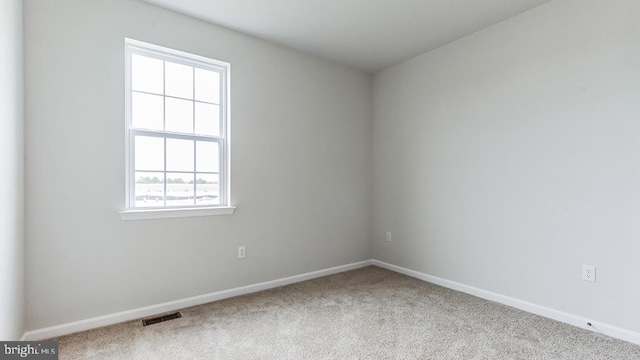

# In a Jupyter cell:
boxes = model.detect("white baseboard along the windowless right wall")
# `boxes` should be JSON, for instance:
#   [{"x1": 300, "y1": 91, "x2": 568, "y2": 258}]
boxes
[{"x1": 371, "y1": 260, "x2": 640, "y2": 345}]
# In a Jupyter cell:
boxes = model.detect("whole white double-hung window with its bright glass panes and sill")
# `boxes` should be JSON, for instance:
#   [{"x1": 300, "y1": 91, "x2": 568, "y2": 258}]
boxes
[{"x1": 121, "y1": 39, "x2": 233, "y2": 219}]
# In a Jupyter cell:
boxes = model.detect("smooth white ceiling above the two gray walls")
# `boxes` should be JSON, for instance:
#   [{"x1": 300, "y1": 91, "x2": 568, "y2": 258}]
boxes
[{"x1": 143, "y1": 0, "x2": 550, "y2": 71}]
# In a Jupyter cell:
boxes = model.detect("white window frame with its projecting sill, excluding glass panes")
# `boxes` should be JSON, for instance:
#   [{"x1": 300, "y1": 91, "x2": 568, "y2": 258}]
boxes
[{"x1": 120, "y1": 38, "x2": 235, "y2": 220}]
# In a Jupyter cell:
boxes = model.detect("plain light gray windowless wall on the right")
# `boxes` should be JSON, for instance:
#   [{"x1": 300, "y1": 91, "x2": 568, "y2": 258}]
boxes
[{"x1": 373, "y1": 0, "x2": 640, "y2": 332}]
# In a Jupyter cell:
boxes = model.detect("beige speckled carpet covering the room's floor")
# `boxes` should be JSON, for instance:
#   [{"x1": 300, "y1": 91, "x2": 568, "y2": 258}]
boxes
[{"x1": 54, "y1": 267, "x2": 640, "y2": 360}]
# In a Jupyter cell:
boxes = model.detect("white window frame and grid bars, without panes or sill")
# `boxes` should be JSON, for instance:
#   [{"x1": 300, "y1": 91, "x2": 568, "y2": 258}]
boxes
[{"x1": 125, "y1": 39, "x2": 230, "y2": 210}]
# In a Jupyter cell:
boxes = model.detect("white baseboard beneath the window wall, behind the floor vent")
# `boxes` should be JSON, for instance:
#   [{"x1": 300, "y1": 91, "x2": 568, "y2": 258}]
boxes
[{"x1": 21, "y1": 260, "x2": 373, "y2": 341}]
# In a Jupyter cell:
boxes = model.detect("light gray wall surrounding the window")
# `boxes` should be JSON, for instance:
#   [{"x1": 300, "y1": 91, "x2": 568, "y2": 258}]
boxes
[{"x1": 25, "y1": 0, "x2": 372, "y2": 330}]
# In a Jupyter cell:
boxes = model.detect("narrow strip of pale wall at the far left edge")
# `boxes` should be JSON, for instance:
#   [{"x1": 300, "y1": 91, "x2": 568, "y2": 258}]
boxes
[{"x1": 0, "y1": 0, "x2": 25, "y2": 340}]
